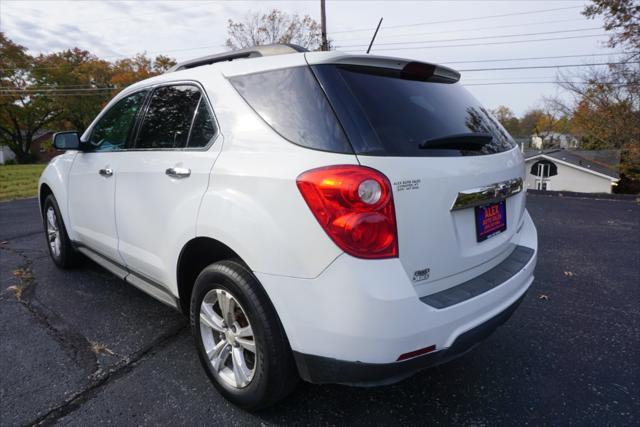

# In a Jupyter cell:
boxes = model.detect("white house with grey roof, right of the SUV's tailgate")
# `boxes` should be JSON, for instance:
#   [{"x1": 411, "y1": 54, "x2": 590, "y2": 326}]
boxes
[{"x1": 524, "y1": 149, "x2": 620, "y2": 193}]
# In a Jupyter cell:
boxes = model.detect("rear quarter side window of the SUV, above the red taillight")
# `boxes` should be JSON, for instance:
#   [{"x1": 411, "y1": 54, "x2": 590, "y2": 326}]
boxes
[{"x1": 230, "y1": 67, "x2": 353, "y2": 154}]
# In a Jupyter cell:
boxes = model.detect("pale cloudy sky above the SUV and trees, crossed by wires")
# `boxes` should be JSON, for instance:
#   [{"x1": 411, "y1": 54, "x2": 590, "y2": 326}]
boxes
[{"x1": 0, "y1": 0, "x2": 615, "y2": 114}]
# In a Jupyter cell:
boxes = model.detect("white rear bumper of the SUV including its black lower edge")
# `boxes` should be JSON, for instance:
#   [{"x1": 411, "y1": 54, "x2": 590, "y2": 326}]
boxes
[{"x1": 255, "y1": 214, "x2": 537, "y2": 384}]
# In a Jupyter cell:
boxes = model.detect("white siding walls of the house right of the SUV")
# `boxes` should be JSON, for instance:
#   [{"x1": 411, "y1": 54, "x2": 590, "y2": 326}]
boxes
[{"x1": 525, "y1": 157, "x2": 612, "y2": 193}]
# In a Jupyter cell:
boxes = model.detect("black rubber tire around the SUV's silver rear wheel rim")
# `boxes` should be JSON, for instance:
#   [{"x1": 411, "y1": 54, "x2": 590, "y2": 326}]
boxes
[{"x1": 190, "y1": 261, "x2": 298, "y2": 410}]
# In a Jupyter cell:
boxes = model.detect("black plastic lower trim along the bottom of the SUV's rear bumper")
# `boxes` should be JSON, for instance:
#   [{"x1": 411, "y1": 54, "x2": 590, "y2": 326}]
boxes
[{"x1": 294, "y1": 295, "x2": 524, "y2": 386}]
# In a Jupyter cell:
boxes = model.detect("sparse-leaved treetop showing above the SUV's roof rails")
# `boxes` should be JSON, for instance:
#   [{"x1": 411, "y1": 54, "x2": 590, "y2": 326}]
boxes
[{"x1": 226, "y1": 9, "x2": 322, "y2": 50}]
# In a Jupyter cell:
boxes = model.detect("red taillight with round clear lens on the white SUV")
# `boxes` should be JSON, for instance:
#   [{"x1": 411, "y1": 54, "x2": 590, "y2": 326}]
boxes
[{"x1": 297, "y1": 165, "x2": 398, "y2": 258}]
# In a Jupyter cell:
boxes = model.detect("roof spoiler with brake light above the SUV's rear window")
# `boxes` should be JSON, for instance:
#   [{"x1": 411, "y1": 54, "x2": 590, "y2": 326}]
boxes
[{"x1": 307, "y1": 55, "x2": 460, "y2": 83}]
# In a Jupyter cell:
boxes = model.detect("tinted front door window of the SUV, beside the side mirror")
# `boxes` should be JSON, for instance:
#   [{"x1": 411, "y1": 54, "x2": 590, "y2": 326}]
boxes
[{"x1": 89, "y1": 91, "x2": 147, "y2": 151}]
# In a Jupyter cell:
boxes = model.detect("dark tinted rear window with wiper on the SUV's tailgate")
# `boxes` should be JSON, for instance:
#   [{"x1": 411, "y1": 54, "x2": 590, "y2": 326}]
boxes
[{"x1": 312, "y1": 65, "x2": 515, "y2": 157}]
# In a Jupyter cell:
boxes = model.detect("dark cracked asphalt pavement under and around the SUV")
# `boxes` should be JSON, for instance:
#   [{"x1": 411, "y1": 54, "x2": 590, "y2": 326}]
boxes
[{"x1": 0, "y1": 196, "x2": 640, "y2": 426}]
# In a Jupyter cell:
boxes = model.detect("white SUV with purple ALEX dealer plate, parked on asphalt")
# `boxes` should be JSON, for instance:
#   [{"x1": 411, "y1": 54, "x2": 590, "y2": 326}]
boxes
[{"x1": 40, "y1": 45, "x2": 537, "y2": 409}]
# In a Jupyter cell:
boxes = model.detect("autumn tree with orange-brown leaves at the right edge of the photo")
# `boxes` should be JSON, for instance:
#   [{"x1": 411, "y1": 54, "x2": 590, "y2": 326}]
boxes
[{"x1": 558, "y1": 0, "x2": 640, "y2": 186}]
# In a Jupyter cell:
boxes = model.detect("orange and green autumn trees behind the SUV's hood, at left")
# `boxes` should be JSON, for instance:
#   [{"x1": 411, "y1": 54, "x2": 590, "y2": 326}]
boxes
[{"x1": 0, "y1": 32, "x2": 176, "y2": 163}]
